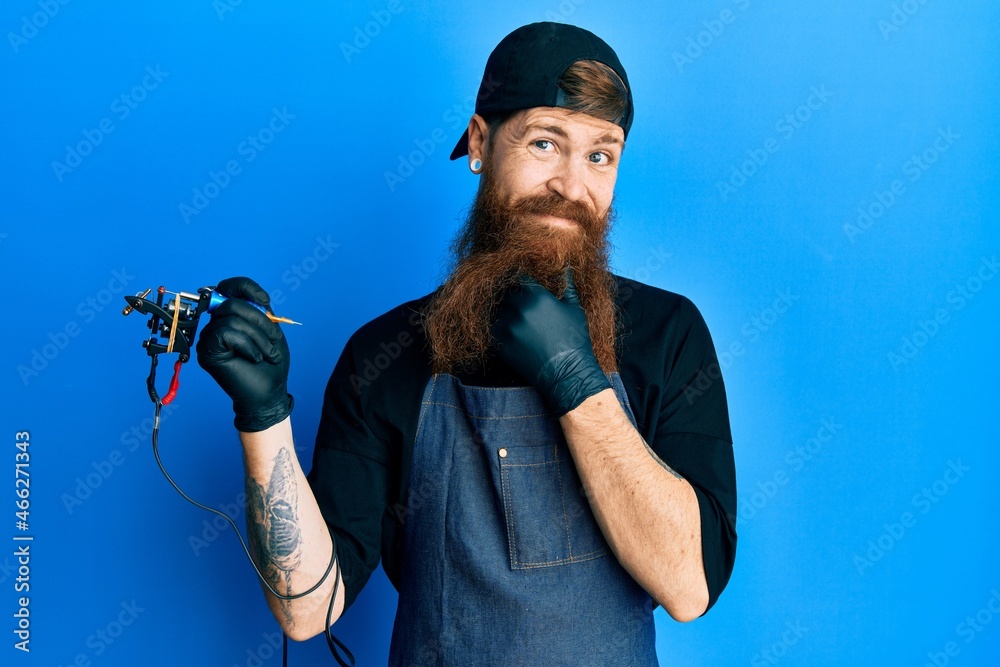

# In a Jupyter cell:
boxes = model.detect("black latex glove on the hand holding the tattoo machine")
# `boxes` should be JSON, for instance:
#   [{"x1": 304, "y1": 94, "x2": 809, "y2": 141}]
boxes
[{"x1": 196, "y1": 278, "x2": 293, "y2": 433}]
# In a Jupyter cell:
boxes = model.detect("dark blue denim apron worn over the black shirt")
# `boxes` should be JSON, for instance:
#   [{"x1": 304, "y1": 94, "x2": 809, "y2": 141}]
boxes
[{"x1": 389, "y1": 373, "x2": 658, "y2": 667}]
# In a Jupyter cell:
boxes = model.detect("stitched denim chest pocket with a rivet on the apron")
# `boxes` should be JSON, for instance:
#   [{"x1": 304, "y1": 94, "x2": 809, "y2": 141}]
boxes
[{"x1": 497, "y1": 442, "x2": 608, "y2": 570}]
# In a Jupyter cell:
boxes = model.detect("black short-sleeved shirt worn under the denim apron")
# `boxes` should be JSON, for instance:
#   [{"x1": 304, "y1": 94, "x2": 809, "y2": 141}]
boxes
[{"x1": 308, "y1": 276, "x2": 736, "y2": 607}]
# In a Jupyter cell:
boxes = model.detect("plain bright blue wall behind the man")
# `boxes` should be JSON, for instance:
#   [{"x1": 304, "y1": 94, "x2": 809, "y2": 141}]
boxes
[{"x1": 0, "y1": 0, "x2": 1000, "y2": 667}]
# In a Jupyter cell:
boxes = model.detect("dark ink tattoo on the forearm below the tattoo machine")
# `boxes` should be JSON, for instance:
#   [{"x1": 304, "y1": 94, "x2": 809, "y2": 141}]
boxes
[{"x1": 246, "y1": 448, "x2": 302, "y2": 623}]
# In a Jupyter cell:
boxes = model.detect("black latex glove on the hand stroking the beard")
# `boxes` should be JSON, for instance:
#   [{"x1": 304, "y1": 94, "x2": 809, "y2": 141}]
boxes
[{"x1": 492, "y1": 270, "x2": 611, "y2": 417}]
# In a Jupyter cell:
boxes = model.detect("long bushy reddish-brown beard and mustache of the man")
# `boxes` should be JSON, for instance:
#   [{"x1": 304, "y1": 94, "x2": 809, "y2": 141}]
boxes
[{"x1": 423, "y1": 166, "x2": 618, "y2": 374}]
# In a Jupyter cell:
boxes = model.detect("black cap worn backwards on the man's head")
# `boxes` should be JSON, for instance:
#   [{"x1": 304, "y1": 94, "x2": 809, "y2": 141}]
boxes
[{"x1": 451, "y1": 21, "x2": 632, "y2": 160}]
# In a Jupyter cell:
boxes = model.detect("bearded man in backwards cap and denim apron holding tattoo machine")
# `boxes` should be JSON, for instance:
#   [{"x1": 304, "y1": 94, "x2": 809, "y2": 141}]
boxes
[{"x1": 198, "y1": 23, "x2": 736, "y2": 665}]
